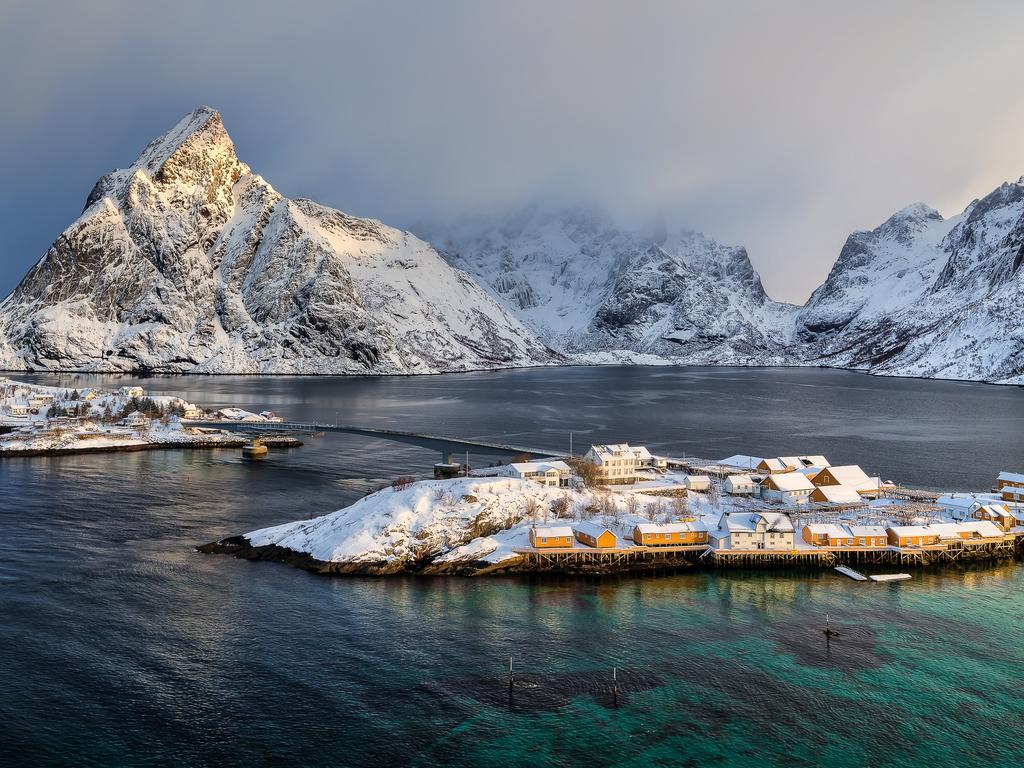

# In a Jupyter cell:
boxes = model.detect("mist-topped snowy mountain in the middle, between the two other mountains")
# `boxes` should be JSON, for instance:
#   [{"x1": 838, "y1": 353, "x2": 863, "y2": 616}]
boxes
[{"x1": 422, "y1": 209, "x2": 795, "y2": 365}]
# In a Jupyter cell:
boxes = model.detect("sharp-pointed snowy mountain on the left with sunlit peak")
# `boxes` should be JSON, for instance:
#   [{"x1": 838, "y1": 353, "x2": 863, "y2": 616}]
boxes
[{"x1": 0, "y1": 106, "x2": 558, "y2": 374}]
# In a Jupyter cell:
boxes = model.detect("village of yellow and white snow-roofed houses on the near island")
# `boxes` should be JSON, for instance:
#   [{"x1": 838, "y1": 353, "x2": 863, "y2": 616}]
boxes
[{"x1": 466, "y1": 443, "x2": 1024, "y2": 567}]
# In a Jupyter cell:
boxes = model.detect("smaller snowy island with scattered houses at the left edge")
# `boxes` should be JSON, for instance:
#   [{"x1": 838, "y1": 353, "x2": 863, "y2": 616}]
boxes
[{"x1": 0, "y1": 378, "x2": 301, "y2": 457}]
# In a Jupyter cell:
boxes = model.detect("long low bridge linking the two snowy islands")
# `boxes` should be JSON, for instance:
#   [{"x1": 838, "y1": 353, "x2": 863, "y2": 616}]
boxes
[{"x1": 181, "y1": 419, "x2": 559, "y2": 461}]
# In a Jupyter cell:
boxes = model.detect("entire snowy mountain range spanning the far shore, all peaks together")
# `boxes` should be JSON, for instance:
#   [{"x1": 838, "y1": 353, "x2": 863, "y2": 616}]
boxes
[{"x1": 0, "y1": 106, "x2": 1024, "y2": 384}]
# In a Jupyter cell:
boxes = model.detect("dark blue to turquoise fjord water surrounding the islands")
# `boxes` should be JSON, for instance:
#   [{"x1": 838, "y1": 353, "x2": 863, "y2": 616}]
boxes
[{"x1": 0, "y1": 368, "x2": 1024, "y2": 766}]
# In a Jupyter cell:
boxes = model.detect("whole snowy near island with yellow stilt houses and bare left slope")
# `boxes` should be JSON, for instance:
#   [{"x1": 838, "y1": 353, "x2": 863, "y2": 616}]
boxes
[{"x1": 200, "y1": 443, "x2": 1024, "y2": 574}]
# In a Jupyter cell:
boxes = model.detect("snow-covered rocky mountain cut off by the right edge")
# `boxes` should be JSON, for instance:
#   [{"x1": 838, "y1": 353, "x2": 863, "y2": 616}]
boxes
[{"x1": 797, "y1": 177, "x2": 1024, "y2": 384}]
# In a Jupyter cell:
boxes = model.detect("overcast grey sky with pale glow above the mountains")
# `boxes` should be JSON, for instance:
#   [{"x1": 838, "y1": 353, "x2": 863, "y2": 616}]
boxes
[{"x1": 0, "y1": 0, "x2": 1024, "y2": 303}]
